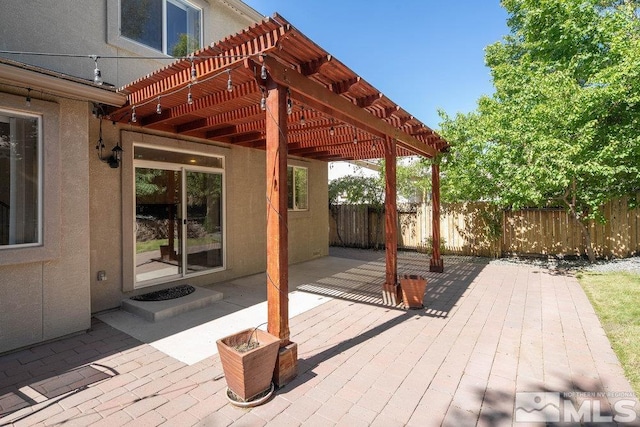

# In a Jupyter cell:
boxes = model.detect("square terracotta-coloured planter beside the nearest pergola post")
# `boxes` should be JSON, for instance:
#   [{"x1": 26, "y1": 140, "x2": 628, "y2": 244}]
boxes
[{"x1": 216, "y1": 328, "x2": 280, "y2": 401}]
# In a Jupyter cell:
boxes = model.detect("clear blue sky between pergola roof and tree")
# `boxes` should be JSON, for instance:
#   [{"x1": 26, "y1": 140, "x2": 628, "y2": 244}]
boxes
[{"x1": 244, "y1": 0, "x2": 508, "y2": 129}]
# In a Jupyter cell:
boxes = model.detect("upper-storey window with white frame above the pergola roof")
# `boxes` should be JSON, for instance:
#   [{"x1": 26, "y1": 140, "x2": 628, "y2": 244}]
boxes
[{"x1": 120, "y1": 0, "x2": 202, "y2": 56}]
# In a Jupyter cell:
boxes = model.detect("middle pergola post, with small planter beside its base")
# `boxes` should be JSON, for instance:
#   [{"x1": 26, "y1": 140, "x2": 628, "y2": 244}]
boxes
[{"x1": 382, "y1": 137, "x2": 399, "y2": 306}]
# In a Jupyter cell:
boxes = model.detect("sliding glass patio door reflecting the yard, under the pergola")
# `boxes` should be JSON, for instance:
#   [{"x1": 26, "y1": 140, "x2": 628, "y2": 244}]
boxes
[{"x1": 135, "y1": 148, "x2": 224, "y2": 287}]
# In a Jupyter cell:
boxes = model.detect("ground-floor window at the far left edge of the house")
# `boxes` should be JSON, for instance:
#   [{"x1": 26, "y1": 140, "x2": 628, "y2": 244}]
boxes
[{"x1": 0, "y1": 110, "x2": 42, "y2": 248}]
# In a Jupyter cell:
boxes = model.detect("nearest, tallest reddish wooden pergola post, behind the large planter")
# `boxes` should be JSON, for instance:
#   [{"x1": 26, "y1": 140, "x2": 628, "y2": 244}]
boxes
[{"x1": 265, "y1": 84, "x2": 298, "y2": 387}]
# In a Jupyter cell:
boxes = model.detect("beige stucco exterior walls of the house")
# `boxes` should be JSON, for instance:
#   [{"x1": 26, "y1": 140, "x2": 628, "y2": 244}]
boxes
[{"x1": 0, "y1": 0, "x2": 329, "y2": 354}]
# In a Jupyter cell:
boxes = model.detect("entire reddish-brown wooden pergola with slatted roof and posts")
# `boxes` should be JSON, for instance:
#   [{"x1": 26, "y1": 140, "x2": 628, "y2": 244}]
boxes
[{"x1": 109, "y1": 14, "x2": 448, "y2": 384}]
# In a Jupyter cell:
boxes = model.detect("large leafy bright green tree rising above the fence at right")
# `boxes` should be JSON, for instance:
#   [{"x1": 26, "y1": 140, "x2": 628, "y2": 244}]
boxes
[{"x1": 441, "y1": 0, "x2": 640, "y2": 260}]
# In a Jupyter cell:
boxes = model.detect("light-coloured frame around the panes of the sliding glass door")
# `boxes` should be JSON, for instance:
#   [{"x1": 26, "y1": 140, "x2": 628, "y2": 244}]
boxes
[{"x1": 132, "y1": 155, "x2": 227, "y2": 289}]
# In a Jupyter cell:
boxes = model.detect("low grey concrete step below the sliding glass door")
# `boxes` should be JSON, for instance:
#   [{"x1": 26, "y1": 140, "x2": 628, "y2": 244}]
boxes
[{"x1": 121, "y1": 286, "x2": 223, "y2": 322}]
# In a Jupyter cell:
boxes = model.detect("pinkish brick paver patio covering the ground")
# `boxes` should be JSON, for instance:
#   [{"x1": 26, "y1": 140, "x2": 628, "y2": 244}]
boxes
[{"x1": 0, "y1": 251, "x2": 640, "y2": 427}]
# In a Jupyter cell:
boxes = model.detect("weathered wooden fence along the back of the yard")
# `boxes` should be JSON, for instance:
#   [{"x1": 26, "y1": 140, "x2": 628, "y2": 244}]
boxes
[{"x1": 329, "y1": 199, "x2": 640, "y2": 258}]
